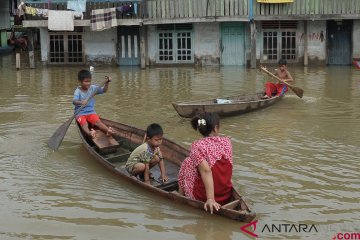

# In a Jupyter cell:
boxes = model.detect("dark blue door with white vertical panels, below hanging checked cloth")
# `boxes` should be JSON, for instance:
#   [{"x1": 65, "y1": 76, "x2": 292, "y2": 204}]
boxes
[{"x1": 118, "y1": 26, "x2": 140, "y2": 66}]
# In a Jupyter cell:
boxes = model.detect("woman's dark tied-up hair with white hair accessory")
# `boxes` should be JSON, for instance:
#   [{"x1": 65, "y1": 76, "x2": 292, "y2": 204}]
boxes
[{"x1": 191, "y1": 112, "x2": 220, "y2": 137}]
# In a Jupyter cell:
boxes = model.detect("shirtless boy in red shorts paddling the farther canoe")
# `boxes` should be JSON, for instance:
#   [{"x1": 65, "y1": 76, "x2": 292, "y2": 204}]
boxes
[{"x1": 262, "y1": 59, "x2": 294, "y2": 99}]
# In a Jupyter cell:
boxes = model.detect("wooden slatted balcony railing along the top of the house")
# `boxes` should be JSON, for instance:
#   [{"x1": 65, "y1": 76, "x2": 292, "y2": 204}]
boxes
[{"x1": 26, "y1": 0, "x2": 360, "y2": 22}]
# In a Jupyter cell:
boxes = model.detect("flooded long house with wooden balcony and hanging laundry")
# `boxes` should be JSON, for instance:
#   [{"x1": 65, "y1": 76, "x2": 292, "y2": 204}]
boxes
[{"x1": 6, "y1": 0, "x2": 360, "y2": 68}]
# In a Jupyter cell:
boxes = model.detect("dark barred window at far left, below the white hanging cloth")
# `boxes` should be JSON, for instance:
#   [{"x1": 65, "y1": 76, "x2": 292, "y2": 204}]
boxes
[{"x1": 49, "y1": 33, "x2": 84, "y2": 64}]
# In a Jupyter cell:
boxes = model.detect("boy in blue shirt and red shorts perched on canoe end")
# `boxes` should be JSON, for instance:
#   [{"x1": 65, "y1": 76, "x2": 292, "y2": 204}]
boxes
[{"x1": 73, "y1": 70, "x2": 114, "y2": 138}]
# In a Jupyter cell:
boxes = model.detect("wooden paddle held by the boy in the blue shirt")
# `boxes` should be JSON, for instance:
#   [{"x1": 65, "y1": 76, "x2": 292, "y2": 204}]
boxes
[{"x1": 48, "y1": 76, "x2": 109, "y2": 150}]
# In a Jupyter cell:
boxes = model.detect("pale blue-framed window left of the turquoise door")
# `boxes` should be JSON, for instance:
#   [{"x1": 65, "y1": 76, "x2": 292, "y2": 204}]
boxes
[{"x1": 157, "y1": 24, "x2": 194, "y2": 63}]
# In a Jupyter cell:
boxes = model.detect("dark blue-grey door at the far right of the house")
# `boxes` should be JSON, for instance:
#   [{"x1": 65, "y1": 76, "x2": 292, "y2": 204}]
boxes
[{"x1": 327, "y1": 20, "x2": 352, "y2": 65}]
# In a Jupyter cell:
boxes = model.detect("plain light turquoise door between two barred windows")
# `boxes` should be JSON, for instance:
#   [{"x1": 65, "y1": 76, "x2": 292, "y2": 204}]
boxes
[{"x1": 220, "y1": 23, "x2": 245, "y2": 65}]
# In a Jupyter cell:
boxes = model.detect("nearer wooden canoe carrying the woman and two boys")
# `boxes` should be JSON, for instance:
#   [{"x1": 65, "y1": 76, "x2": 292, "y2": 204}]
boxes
[{"x1": 76, "y1": 119, "x2": 256, "y2": 222}]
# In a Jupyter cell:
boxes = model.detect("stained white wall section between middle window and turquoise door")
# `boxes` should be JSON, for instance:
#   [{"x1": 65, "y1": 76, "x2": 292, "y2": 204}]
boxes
[{"x1": 194, "y1": 23, "x2": 221, "y2": 65}]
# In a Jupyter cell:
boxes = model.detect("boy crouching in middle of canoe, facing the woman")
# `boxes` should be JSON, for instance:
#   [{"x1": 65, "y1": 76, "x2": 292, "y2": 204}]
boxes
[{"x1": 125, "y1": 123, "x2": 169, "y2": 184}]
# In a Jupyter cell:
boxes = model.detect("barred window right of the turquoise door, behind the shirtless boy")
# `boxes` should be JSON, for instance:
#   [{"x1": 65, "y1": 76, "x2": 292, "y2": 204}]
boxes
[{"x1": 261, "y1": 21, "x2": 297, "y2": 62}]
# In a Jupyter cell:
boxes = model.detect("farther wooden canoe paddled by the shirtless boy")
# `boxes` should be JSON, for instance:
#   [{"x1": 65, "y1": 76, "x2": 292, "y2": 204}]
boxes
[{"x1": 172, "y1": 92, "x2": 284, "y2": 118}]
